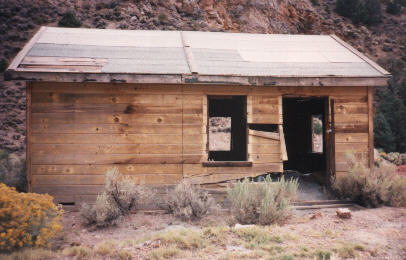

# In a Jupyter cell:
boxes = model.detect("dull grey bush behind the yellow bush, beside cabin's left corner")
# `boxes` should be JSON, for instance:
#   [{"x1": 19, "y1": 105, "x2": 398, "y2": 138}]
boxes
[{"x1": 0, "y1": 149, "x2": 27, "y2": 191}]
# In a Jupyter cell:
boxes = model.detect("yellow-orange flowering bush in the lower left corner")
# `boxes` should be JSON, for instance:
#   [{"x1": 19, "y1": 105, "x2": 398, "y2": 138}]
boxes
[{"x1": 0, "y1": 183, "x2": 63, "y2": 252}]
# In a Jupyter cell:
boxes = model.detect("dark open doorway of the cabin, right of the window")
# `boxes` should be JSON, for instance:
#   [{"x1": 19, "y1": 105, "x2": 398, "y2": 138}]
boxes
[{"x1": 282, "y1": 97, "x2": 329, "y2": 184}]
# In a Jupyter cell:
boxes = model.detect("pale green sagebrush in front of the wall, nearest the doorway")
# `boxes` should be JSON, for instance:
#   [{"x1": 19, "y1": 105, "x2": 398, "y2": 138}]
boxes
[{"x1": 228, "y1": 175, "x2": 298, "y2": 225}]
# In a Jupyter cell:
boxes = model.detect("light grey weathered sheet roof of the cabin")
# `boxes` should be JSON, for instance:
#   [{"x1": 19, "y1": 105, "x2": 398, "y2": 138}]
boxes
[{"x1": 10, "y1": 27, "x2": 389, "y2": 77}]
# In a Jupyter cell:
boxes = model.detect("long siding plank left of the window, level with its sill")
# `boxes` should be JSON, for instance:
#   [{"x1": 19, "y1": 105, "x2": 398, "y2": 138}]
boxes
[{"x1": 31, "y1": 153, "x2": 206, "y2": 165}]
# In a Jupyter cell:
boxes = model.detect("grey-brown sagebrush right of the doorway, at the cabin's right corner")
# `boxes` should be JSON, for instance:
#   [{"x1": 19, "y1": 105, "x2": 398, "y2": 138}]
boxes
[{"x1": 332, "y1": 155, "x2": 406, "y2": 207}]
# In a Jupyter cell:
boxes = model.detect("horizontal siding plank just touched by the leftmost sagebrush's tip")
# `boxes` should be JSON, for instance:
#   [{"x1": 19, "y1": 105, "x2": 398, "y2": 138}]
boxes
[{"x1": 32, "y1": 162, "x2": 182, "y2": 175}]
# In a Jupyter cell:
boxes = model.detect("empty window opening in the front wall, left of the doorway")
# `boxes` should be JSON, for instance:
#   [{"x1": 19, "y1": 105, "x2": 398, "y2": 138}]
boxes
[{"x1": 208, "y1": 96, "x2": 247, "y2": 161}]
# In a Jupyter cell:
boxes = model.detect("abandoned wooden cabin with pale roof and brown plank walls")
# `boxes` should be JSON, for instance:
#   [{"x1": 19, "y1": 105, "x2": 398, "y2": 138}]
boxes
[{"x1": 6, "y1": 27, "x2": 390, "y2": 204}]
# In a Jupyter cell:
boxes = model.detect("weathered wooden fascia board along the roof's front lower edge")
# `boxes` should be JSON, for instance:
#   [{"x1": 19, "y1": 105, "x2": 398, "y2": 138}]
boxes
[{"x1": 4, "y1": 68, "x2": 390, "y2": 87}]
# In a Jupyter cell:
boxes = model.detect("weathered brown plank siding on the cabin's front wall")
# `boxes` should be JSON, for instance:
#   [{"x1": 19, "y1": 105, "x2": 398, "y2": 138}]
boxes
[{"x1": 27, "y1": 82, "x2": 371, "y2": 202}]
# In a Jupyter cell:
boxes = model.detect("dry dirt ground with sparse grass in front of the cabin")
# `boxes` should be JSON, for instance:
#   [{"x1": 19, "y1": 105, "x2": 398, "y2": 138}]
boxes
[{"x1": 50, "y1": 207, "x2": 406, "y2": 259}]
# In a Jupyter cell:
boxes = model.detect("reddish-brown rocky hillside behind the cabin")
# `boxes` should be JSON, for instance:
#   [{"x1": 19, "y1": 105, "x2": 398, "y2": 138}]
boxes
[{"x1": 0, "y1": 0, "x2": 406, "y2": 156}]
